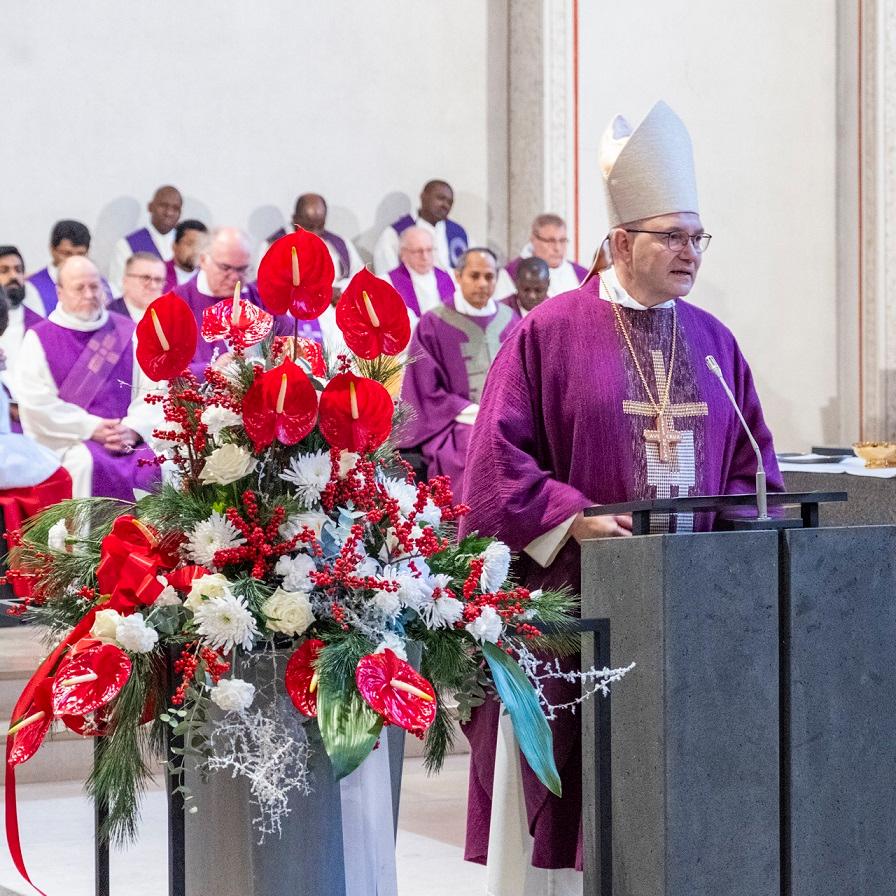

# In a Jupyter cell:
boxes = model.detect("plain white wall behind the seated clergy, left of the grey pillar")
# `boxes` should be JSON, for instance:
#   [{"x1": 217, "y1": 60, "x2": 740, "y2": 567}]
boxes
[{"x1": 0, "y1": 0, "x2": 507, "y2": 269}]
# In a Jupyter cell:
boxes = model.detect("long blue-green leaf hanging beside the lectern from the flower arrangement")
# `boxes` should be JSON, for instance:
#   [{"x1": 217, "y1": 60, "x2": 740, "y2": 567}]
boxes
[{"x1": 482, "y1": 643, "x2": 561, "y2": 796}]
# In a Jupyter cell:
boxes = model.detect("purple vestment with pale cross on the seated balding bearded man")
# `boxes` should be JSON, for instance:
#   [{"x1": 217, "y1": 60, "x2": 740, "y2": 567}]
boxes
[{"x1": 34, "y1": 315, "x2": 160, "y2": 501}]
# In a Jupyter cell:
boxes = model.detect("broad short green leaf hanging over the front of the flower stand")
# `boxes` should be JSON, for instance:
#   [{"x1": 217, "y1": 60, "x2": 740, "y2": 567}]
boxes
[{"x1": 317, "y1": 679, "x2": 383, "y2": 780}]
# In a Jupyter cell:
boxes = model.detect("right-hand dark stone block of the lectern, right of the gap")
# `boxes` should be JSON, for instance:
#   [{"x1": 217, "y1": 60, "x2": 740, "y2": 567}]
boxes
[{"x1": 781, "y1": 528, "x2": 896, "y2": 896}]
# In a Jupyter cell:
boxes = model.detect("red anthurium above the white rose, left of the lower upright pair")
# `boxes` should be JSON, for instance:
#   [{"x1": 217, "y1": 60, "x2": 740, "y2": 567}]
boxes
[{"x1": 243, "y1": 361, "x2": 317, "y2": 451}]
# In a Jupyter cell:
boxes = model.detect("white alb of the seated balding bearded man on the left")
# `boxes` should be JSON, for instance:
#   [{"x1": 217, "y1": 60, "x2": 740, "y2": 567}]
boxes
[{"x1": 14, "y1": 307, "x2": 164, "y2": 498}]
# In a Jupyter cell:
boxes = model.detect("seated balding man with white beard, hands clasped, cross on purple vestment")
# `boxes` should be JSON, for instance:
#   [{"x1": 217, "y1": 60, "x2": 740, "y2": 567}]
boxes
[{"x1": 15, "y1": 257, "x2": 162, "y2": 501}]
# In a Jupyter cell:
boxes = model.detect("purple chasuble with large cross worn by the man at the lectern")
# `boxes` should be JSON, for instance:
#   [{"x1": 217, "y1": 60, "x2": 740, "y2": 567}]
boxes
[{"x1": 460, "y1": 277, "x2": 784, "y2": 868}]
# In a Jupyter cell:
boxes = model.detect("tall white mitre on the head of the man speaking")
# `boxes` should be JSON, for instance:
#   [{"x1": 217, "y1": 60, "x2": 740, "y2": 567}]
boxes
[{"x1": 600, "y1": 100, "x2": 699, "y2": 228}]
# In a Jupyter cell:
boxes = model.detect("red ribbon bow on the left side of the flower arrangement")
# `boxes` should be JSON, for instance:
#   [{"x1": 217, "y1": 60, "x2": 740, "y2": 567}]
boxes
[{"x1": 96, "y1": 514, "x2": 166, "y2": 613}]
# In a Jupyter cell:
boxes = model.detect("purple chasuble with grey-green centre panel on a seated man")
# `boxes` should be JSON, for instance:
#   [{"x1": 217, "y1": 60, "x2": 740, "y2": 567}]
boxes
[{"x1": 399, "y1": 305, "x2": 519, "y2": 501}]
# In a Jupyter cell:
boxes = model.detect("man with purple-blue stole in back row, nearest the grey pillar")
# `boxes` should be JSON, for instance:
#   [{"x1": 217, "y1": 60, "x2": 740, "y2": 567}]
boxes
[{"x1": 373, "y1": 180, "x2": 470, "y2": 277}]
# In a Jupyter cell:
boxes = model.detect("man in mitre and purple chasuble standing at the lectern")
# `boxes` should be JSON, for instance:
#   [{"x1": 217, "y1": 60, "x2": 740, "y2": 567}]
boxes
[{"x1": 460, "y1": 102, "x2": 783, "y2": 896}]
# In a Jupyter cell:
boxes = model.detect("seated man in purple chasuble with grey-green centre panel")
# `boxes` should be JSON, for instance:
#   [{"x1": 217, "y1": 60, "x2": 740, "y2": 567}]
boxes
[{"x1": 399, "y1": 248, "x2": 520, "y2": 501}]
